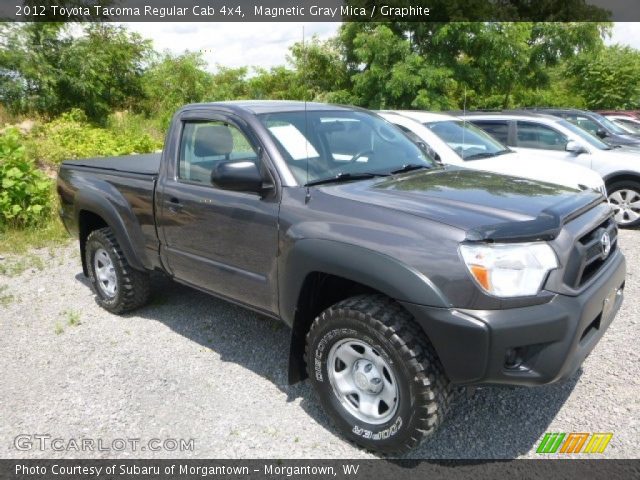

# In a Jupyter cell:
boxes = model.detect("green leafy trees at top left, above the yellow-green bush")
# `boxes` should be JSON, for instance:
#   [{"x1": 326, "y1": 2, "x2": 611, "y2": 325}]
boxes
[{"x1": 0, "y1": 23, "x2": 151, "y2": 123}]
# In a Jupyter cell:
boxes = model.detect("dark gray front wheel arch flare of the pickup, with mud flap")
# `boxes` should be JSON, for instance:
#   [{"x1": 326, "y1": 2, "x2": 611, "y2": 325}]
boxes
[{"x1": 279, "y1": 239, "x2": 449, "y2": 383}]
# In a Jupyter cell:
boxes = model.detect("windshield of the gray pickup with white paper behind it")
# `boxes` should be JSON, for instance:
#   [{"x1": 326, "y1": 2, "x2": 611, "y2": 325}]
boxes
[{"x1": 259, "y1": 110, "x2": 436, "y2": 185}]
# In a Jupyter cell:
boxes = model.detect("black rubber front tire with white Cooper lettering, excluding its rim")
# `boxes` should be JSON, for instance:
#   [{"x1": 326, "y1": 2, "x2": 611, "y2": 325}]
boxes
[{"x1": 305, "y1": 295, "x2": 453, "y2": 454}]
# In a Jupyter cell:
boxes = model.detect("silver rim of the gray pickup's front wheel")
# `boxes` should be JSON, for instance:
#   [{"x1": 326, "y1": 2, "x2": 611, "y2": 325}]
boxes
[{"x1": 327, "y1": 338, "x2": 399, "y2": 424}]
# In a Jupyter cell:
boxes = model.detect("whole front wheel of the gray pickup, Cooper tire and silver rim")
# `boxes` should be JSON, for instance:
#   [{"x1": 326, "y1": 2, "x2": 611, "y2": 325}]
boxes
[{"x1": 305, "y1": 295, "x2": 452, "y2": 453}]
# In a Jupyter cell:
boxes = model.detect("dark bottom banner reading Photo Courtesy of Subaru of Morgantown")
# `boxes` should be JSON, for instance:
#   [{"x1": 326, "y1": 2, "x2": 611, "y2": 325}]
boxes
[{"x1": 0, "y1": 459, "x2": 640, "y2": 480}]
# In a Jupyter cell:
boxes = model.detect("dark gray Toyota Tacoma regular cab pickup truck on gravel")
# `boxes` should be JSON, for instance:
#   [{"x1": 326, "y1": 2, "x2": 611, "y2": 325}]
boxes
[{"x1": 58, "y1": 101, "x2": 625, "y2": 452}]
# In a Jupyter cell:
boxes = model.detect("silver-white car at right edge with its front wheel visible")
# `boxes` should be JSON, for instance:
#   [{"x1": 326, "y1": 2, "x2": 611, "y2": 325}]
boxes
[{"x1": 466, "y1": 112, "x2": 640, "y2": 227}]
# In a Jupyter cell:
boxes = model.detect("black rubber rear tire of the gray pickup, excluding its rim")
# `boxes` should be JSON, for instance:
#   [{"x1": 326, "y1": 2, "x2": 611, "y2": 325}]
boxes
[{"x1": 85, "y1": 228, "x2": 150, "y2": 314}]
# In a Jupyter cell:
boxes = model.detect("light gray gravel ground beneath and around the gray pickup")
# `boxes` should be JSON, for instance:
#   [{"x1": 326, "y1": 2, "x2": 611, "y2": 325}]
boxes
[{"x1": 0, "y1": 231, "x2": 640, "y2": 458}]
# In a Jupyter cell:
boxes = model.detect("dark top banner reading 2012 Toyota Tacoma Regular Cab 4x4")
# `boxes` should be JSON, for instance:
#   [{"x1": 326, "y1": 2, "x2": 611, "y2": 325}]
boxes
[{"x1": 0, "y1": 0, "x2": 640, "y2": 22}]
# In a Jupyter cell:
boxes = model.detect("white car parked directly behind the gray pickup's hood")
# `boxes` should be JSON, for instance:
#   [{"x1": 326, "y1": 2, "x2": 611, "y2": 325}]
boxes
[{"x1": 378, "y1": 110, "x2": 607, "y2": 196}]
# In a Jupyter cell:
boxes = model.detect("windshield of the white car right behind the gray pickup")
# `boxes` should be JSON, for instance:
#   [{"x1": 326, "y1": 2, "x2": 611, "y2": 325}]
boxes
[{"x1": 424, "y1": 120, "x2": 511, "y2": 160}]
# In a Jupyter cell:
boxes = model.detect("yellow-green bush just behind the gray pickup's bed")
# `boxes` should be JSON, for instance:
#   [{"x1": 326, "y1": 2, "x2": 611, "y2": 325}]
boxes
[{"x1": 29, "y1": 109, "x2": 162, "y2": 164}]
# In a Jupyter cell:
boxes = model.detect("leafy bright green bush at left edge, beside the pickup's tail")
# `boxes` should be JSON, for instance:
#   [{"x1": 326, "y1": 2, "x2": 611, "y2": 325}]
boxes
[{"x1": 0, "y1": 128, "x2": 52, "y2": 228}]
